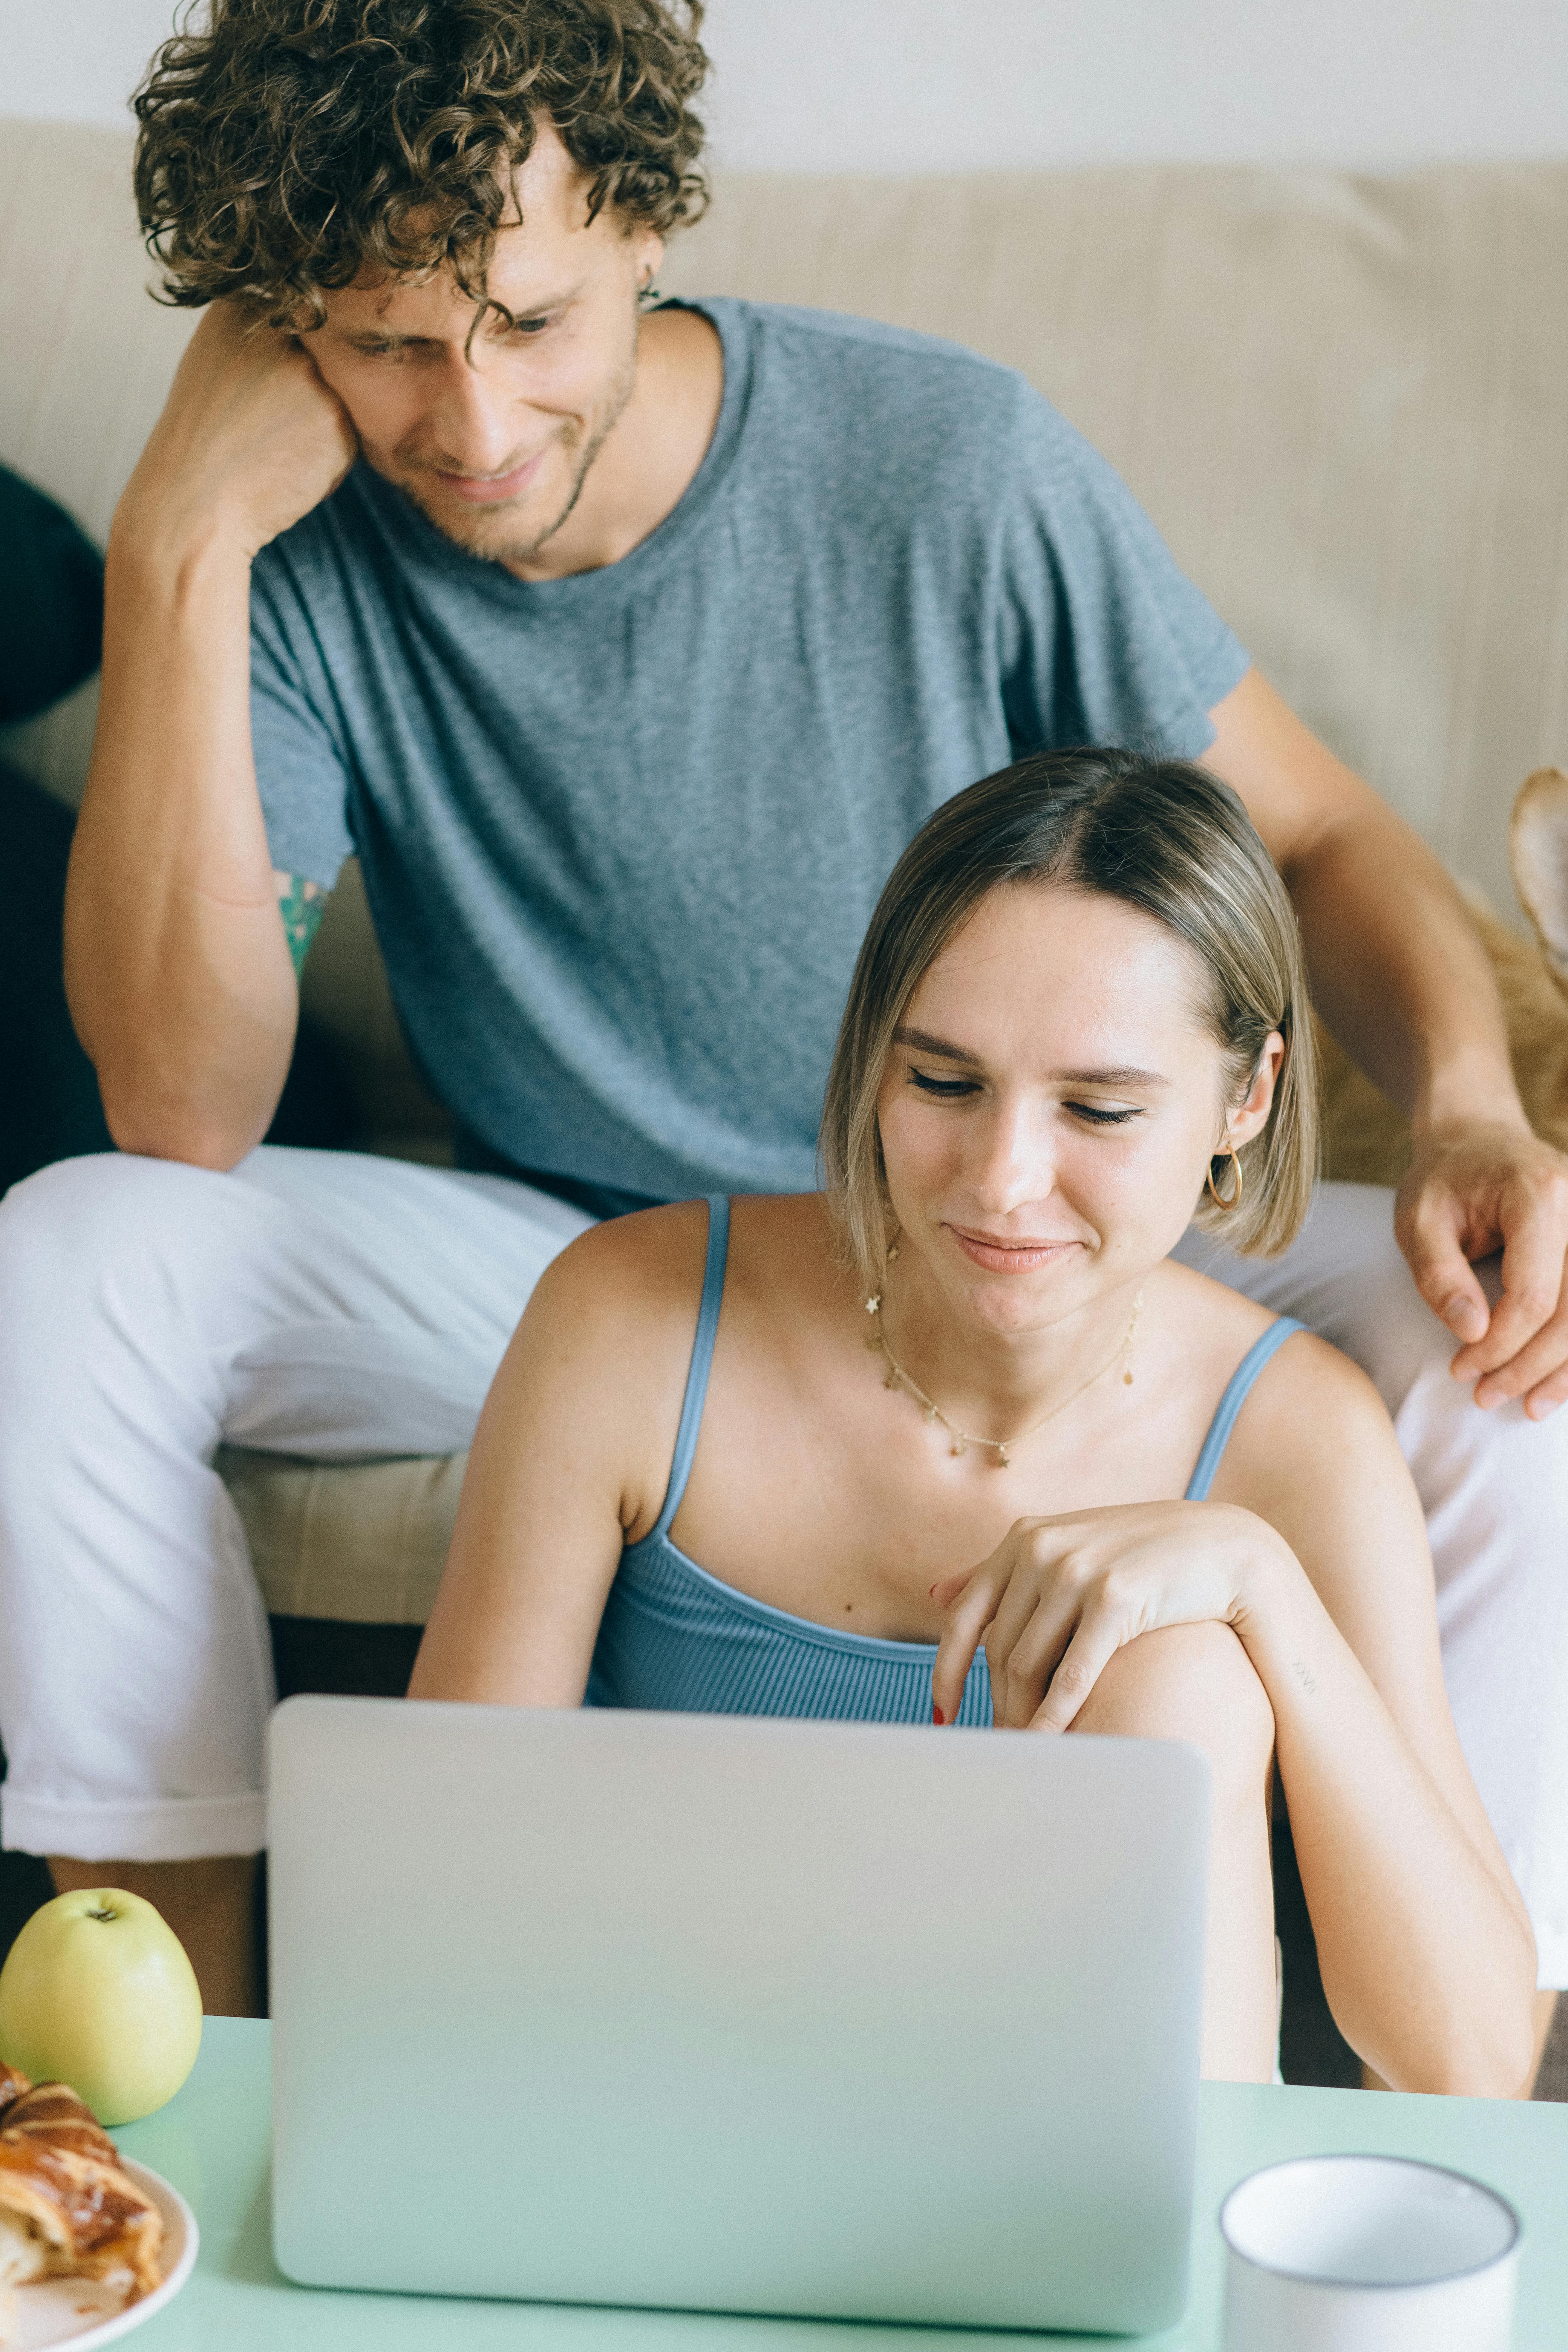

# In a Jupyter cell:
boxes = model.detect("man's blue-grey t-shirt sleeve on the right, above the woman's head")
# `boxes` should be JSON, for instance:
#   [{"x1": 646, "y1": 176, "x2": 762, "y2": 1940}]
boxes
[{"x1": 999, "y1": 383, "x2": 1248, "y2": 760}]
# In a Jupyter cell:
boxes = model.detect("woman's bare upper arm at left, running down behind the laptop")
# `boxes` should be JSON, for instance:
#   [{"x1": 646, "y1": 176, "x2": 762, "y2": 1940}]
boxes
[{"x1": 409, "y1": 1202, "x2": 707, "y2": 1707}]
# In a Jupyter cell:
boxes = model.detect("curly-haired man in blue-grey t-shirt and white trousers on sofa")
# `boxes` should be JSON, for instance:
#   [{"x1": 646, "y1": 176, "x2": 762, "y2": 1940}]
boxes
[{"x1": 0, "y1": 0, "x2": 1568, "y2": 2060}]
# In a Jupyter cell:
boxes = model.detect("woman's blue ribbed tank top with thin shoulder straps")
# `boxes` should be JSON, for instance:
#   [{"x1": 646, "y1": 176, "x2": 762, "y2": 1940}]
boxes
[{"x1": 585, "y1": 1193, "x2": 1302, "y2": 1726}]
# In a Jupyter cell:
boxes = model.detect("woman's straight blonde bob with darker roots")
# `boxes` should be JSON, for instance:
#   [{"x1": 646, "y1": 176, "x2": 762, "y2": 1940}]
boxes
[{"x1": 821, "y1": 750, "x2": 1317, "y2": 1294}]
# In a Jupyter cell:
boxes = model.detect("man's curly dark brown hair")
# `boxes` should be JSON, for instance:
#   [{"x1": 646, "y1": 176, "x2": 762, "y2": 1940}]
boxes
[{"x1": 134, "y1": 0, "x2": 707, "y2": 332}]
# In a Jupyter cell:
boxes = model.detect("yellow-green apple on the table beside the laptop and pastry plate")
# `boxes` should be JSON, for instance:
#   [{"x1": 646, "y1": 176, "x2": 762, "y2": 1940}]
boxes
[{"x1": 0, "y1": 1886, "x2": 202, "y2": 2128}]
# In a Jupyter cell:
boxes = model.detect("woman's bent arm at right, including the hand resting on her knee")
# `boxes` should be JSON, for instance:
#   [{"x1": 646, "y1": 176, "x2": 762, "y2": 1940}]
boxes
[{"x1": 933, "y1": 1338, "x2": 1535, "y2": 2096}]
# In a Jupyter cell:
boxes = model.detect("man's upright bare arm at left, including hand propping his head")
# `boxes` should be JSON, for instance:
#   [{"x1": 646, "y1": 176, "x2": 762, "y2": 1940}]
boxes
[{"x1": 66, "y1": 303, "x2": 355, "y2": 1169}]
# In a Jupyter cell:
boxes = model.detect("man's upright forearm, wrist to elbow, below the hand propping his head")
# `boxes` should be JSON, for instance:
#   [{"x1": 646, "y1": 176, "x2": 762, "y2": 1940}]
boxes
[{"x1": 66, "y1": 518, "x2": 296, "y2": 1167}]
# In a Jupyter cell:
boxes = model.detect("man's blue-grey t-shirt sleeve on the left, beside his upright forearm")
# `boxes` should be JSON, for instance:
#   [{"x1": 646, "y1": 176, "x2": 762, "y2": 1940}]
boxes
[{"x1": 251, "y1": 548, "x2": 355, "y2": 889}]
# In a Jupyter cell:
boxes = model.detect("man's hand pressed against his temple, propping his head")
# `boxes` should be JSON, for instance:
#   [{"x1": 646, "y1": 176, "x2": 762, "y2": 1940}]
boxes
[{"x1": 115, "y1": 301, "x2": 360, "y2": 562}]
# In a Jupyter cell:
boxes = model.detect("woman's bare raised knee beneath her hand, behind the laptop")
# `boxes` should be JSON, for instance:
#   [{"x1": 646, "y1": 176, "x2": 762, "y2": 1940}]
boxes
[{"x1": 1074, "y1": 1620, "x2": 1274, "y2": 1795}]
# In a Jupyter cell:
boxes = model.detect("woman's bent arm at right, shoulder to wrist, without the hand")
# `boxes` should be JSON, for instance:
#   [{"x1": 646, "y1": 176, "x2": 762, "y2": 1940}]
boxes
[{"x1": 1215, "y1": 1338, "x2": 1535, "y2": 2096}]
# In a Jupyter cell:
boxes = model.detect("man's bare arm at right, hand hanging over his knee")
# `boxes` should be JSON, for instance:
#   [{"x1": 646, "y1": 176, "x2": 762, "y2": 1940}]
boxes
[{"x1": 1206, "y1": 670, "x2": 1568, "y2": 1416}]
